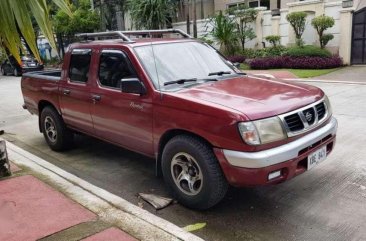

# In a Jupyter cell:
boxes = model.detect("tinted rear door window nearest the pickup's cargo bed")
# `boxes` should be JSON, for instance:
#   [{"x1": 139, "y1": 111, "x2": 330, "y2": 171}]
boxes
[{"x1": 69, "y1": 49, "x2": 91, "y2": 83}]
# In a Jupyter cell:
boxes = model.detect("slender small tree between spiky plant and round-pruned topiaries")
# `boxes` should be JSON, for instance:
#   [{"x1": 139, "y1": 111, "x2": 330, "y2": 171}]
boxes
[{"x1": 228, "y1": 5, "x2": 258, "y2": 50}]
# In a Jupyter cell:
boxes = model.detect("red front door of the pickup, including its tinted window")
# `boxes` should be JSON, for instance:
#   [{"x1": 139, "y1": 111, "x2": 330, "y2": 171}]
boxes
[{"x1": 91, "y1": 50, "x2": 154, "y2": 156}]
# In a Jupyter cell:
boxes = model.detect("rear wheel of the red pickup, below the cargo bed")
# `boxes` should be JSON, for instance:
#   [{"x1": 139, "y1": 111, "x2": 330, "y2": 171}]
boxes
[{"x1": 40, "y1": 106, "x2": 74, "y2": 151}]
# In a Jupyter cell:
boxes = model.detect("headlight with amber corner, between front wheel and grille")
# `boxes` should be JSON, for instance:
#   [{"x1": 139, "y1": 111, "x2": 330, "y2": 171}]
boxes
[{"x1": 239, "y1": 117, "x2": 286, "y2": 145}]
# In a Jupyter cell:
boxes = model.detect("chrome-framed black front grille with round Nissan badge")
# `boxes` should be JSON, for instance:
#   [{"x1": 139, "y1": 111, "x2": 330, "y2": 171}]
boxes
[{"x1": 279, "y1": 100, "x2": 328, "y2": 137}]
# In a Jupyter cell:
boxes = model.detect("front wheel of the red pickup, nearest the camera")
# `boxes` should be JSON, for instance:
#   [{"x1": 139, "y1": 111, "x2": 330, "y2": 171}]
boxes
[{"x1": 162, "y1": 135, "x2": 228, "y2": 210}]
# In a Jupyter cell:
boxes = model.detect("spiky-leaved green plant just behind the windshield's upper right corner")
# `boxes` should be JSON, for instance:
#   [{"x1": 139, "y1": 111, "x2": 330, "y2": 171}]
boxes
[{"x1": 210, "y1": 11, "x2": 238, "y2": 55}]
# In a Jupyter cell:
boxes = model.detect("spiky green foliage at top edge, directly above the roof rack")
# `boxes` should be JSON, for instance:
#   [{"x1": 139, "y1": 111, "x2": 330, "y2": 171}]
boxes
[{"x1": 127, "y1": 0, "x2": 176, "y2": 29}]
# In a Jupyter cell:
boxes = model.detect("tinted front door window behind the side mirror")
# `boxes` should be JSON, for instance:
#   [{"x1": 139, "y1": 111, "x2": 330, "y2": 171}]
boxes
[{"x1": 99, "y1": 50, "x2": 137, "y2": 88}]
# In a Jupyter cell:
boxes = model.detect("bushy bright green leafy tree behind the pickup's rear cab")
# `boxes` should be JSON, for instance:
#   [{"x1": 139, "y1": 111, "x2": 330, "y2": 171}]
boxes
[{"x1": 55, "y1": 0, "x2": 100, "y2": 38}]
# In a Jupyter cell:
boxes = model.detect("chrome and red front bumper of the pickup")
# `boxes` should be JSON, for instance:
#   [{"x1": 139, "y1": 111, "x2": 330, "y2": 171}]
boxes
[{"x1": 214, "y1": 117, "x2": 338, "y2": 186}]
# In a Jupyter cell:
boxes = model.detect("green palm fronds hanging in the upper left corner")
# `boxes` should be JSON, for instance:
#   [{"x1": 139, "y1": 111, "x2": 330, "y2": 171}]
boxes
[{"x1": 0, "y1": 0, "x2": 71, "y2": 63}]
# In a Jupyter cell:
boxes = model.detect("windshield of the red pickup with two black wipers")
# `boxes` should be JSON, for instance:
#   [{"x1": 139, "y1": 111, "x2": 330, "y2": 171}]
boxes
[{"x1": 135, "y1": 42, "x2": 235, "y2": 90}]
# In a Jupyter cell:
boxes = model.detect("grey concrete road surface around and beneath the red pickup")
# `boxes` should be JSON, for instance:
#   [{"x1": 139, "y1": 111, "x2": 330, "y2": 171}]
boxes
[{"x1": 0, "y1": 76, "x2": 366, "y2": 241}]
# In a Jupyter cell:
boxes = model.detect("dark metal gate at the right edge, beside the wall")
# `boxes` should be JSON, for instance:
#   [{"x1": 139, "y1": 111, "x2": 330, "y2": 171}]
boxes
[{"x1": 351, "y1": 8, "x2": 366, "y2": 64}]
